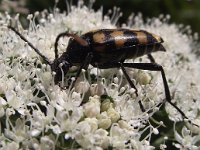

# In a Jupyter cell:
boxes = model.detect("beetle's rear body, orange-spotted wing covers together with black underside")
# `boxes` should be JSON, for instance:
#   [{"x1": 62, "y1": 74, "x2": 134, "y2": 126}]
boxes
[{"x1": 82, "y1": 29, "x2": 165, "y2": 63}]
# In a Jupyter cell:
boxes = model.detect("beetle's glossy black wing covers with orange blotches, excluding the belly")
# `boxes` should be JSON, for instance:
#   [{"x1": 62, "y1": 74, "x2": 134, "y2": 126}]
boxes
[{"x1": 83, "y1": 29, "x2": 163, "y2": 49}]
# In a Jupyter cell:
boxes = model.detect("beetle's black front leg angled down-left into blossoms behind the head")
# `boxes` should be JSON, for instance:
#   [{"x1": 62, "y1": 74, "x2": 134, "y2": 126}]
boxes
[{"x1": 71, "y1": 52, "x2": 93, "y2": 88}]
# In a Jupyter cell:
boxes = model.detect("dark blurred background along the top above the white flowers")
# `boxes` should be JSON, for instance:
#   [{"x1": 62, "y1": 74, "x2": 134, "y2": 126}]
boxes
[{"x1": 0, "y1": 0, "x2": 200, "y2": 36}]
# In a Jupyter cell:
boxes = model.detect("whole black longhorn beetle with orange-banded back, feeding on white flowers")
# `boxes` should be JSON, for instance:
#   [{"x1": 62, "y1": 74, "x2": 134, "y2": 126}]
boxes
[{"x1": 8, "y1": 26, "x2": 198, "y2": 126}]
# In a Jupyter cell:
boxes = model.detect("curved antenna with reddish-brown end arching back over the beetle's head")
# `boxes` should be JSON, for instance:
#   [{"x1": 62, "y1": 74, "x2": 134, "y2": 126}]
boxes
[{"x1": 54, "y1": 31, "x2": 88, "y2": 59}]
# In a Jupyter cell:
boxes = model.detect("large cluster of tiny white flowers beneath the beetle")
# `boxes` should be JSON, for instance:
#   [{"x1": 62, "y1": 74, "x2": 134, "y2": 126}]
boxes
[{"x1": 0, "y1": 1, "x2": 200, "y2": 150}]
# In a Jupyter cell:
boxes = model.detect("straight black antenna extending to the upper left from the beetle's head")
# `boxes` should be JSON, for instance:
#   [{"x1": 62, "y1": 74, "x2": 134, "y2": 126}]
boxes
[{"x1": 8, "y1": 26, "x2": 52, "y2": 66}]
